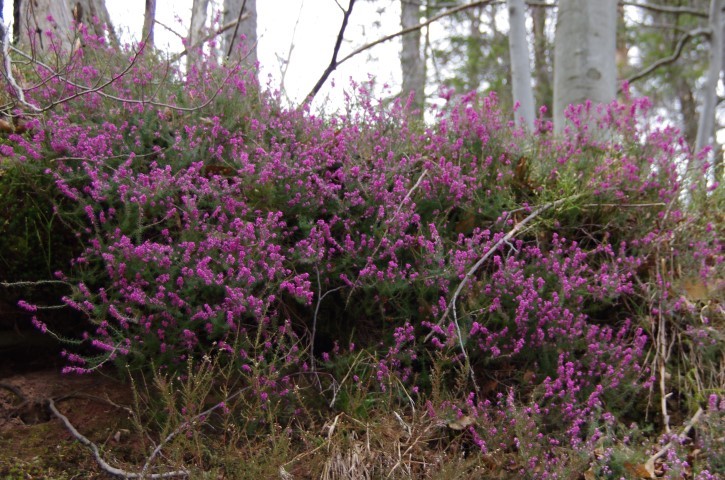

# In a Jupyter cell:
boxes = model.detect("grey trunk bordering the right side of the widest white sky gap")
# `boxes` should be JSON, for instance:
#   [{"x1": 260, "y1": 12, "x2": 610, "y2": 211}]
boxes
[{"x1": 400, "y1": 0, "x2": 425, "y2": 113}]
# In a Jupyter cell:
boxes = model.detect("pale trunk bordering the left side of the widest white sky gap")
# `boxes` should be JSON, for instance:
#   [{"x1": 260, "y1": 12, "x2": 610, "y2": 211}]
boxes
[{"x1": 222, "y1": 0, "x2": 257, "y2": 65}]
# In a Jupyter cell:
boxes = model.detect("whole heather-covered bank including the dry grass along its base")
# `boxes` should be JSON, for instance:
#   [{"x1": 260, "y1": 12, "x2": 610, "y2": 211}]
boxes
[{"x1": 0, "y1": 31, "x2": 725, "y2": 479}]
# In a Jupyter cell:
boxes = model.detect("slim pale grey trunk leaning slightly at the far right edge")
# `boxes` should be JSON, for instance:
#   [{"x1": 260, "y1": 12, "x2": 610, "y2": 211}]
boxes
[{"x1": 695, "y1": 0, "x2": 723, "y2": 156}]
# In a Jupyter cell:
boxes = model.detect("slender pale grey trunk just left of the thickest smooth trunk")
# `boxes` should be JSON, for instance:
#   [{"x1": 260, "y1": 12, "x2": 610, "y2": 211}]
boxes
[{"x1": 508, "y1": 0, "x2": 536, "y2": 131}]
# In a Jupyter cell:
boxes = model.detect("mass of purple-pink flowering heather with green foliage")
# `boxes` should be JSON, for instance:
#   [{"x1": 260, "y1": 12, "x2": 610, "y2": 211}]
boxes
[{"x1": 4, "y1": 29, "x2": 723, "y2": 478}]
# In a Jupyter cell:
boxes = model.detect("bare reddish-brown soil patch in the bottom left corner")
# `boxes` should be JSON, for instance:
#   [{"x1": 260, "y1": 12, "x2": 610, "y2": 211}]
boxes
[{"x1": 0, "y1": 344, "x2": 138, "y2": 480}]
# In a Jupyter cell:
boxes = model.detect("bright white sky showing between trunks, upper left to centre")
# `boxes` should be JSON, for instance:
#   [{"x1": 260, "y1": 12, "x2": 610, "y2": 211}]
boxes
[{"x1": 106, "y1": 0, "x2": 401, "y2": 109}]
